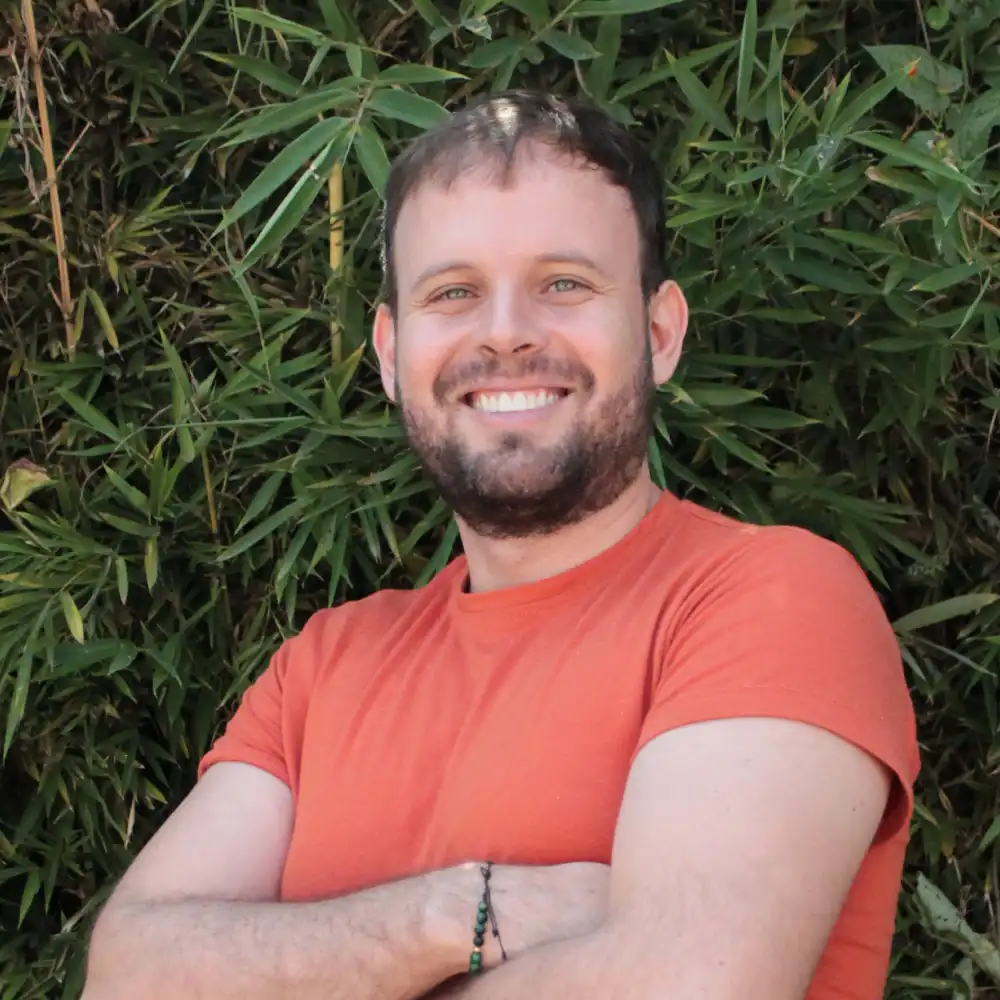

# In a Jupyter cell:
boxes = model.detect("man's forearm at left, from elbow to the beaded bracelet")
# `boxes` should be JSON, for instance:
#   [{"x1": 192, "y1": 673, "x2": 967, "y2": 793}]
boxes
[{"x1": 84, "y1": 869, "x2": 476, "y2": 1000}]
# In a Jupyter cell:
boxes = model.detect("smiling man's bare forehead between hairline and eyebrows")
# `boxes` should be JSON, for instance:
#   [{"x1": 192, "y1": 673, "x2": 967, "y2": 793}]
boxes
[{"x1": 393, "y1": 149, "x2": 639, "y2": 289}]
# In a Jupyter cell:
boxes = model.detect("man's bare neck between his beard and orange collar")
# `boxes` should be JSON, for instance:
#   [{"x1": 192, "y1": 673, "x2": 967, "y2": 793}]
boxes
[{"x1": 458, "y1": 466, "x2": 660, "y2": 593}]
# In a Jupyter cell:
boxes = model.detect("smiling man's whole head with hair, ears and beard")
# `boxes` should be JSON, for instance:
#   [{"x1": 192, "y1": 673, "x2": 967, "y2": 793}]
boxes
[{"x1": 375, "y1": 92, "x2": 687, "y2": 537}]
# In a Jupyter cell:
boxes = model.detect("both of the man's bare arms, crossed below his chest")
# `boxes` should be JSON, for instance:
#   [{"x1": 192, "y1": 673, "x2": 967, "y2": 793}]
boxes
[{"x1": 84, "y1": 719, "x2": 892, "y2": 1000}]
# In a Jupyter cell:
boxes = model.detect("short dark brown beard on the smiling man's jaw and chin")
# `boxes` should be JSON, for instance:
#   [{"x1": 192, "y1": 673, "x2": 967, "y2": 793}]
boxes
[{"x1": 397, "y1": 341, "x2": 656, "y2": 539}]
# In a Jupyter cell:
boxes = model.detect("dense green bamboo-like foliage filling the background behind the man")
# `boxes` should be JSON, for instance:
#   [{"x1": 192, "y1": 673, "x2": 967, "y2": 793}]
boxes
[{"x1": 0, "y1": 0, "x2": 1000, "y2": 1000}]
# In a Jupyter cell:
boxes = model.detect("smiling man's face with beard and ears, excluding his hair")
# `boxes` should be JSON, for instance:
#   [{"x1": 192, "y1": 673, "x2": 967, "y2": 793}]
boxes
[{"x1": 375, "y1": 147, "x2": 686, "y2": 537}]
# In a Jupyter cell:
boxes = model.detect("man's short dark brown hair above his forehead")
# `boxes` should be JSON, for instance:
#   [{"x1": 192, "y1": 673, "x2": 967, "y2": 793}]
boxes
[{"x1": 381, "y1": 90, "x2": 666, "y2": 309}]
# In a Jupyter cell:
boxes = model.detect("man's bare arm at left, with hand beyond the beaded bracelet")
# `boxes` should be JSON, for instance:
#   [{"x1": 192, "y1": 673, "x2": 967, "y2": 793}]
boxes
[{"x1": 83, "y1": 764, "x2": 607, "y2": 1000}]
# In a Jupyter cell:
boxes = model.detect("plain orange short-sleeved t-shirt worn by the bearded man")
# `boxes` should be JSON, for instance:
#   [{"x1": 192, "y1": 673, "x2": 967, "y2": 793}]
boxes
[{"x1": 201, "y1": 493, "x2": 919, "y2": 1000}]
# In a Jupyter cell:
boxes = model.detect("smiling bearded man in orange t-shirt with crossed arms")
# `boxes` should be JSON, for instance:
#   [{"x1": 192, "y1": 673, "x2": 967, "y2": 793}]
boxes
[{"x1": 85, "y1": 93, "x2": 918, "y2": 1000}]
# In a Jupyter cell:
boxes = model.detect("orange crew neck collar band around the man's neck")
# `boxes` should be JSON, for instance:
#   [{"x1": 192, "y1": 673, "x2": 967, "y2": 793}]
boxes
[{"x1": 451, "y1": 490, "x2": 681, "y2": 615}]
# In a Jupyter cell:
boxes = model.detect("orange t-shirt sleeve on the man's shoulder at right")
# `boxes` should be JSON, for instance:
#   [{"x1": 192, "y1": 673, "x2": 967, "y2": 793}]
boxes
[{"x1": 636, "y1": 527, "x2": 919, "y2": 836}]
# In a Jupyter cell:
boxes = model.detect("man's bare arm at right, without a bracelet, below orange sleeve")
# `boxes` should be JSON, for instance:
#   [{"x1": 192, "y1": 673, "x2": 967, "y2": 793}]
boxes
[{"x1": 436, "y1": 719, "x2": 890, "y2": 1000}]
